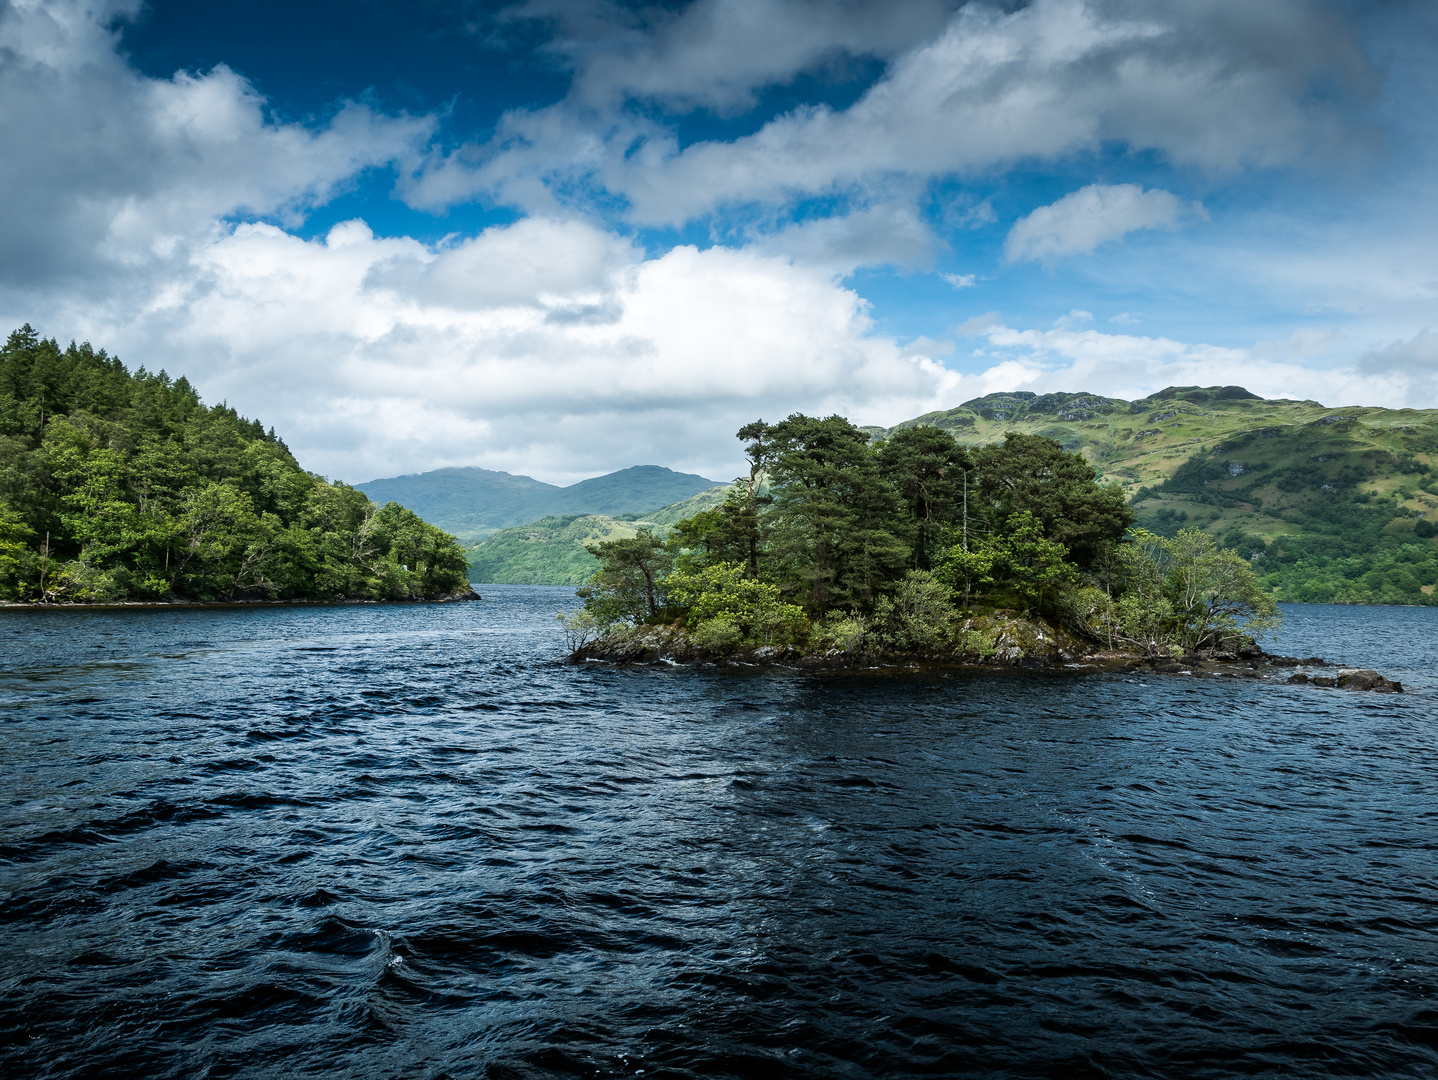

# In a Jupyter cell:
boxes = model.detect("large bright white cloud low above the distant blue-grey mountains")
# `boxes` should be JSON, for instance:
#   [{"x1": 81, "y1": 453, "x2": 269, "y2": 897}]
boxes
[{"x1": 28, "y1": 219, "x2": 955, "y2": 480}]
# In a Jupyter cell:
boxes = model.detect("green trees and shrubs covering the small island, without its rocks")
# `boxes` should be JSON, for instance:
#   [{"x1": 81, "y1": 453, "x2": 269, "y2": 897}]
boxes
[{"x1": 580, "y1": 413, "x2": 1236, "y2": 649}]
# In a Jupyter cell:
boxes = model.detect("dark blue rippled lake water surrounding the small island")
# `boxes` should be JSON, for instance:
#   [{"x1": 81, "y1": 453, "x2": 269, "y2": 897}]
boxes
[{"x1": 0, "y1": 587, "x2": 1438, "y2": 1077}]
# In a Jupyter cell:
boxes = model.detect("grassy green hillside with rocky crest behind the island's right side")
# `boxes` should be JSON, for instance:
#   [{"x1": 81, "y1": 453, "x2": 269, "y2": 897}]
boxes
[{"x1": 864, "y1": 387, "x2": 1438, "y2": 604}]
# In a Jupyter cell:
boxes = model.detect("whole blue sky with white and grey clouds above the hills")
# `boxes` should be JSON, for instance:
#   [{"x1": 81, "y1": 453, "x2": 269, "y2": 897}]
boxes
[{"x1": 0, "y1": 0, "x2": 1438, "y2": 483}]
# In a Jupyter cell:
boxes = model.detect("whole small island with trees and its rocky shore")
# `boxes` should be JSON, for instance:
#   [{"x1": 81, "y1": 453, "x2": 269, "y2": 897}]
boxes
[{"x1": 561, "y1": 414, "x2": 1399, "y2": 690}]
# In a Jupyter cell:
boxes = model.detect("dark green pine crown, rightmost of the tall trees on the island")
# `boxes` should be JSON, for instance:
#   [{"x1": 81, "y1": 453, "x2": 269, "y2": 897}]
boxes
[{"x1": 974, "y1": 431, "x2": 1135, "y2": 568}]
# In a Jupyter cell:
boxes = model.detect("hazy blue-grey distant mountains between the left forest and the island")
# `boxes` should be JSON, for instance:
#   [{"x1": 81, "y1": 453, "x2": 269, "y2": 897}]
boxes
[{"x1": 355, "y1": 465, "x2": 715, "y2": 541}]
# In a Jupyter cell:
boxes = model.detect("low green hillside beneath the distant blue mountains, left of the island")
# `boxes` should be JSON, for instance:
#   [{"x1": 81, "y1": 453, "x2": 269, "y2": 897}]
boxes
[{"x1": 467, "y1": 486, "x2": 729, "y2": 585}]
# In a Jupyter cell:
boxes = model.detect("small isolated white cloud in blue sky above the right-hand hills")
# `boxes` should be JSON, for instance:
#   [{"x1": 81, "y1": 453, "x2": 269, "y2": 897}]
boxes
[{"x1": 1004, "y1": 184, "x2": 1206, "y2": 262}]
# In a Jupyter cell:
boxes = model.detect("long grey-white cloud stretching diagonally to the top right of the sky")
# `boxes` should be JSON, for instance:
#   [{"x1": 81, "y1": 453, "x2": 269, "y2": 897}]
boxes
[{"x1": 419, "y1": 0, "x2": 1363, "y2": 224}]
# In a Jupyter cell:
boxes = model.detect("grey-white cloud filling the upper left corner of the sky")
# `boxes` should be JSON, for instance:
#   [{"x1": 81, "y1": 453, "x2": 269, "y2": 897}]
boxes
[{"x1": 0, "y1": 0, "x2": 433, "y2": 288}]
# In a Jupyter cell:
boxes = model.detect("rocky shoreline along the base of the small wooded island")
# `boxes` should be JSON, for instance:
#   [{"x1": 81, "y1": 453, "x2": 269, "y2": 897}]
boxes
[{"x1": 569, "y1": 613, "x2": 1403, "y2": 693}]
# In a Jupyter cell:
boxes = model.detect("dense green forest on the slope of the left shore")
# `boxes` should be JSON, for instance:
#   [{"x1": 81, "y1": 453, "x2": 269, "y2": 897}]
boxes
[{"x1": 0, "y1": 325, "x2": 467, "y2": 603}]
